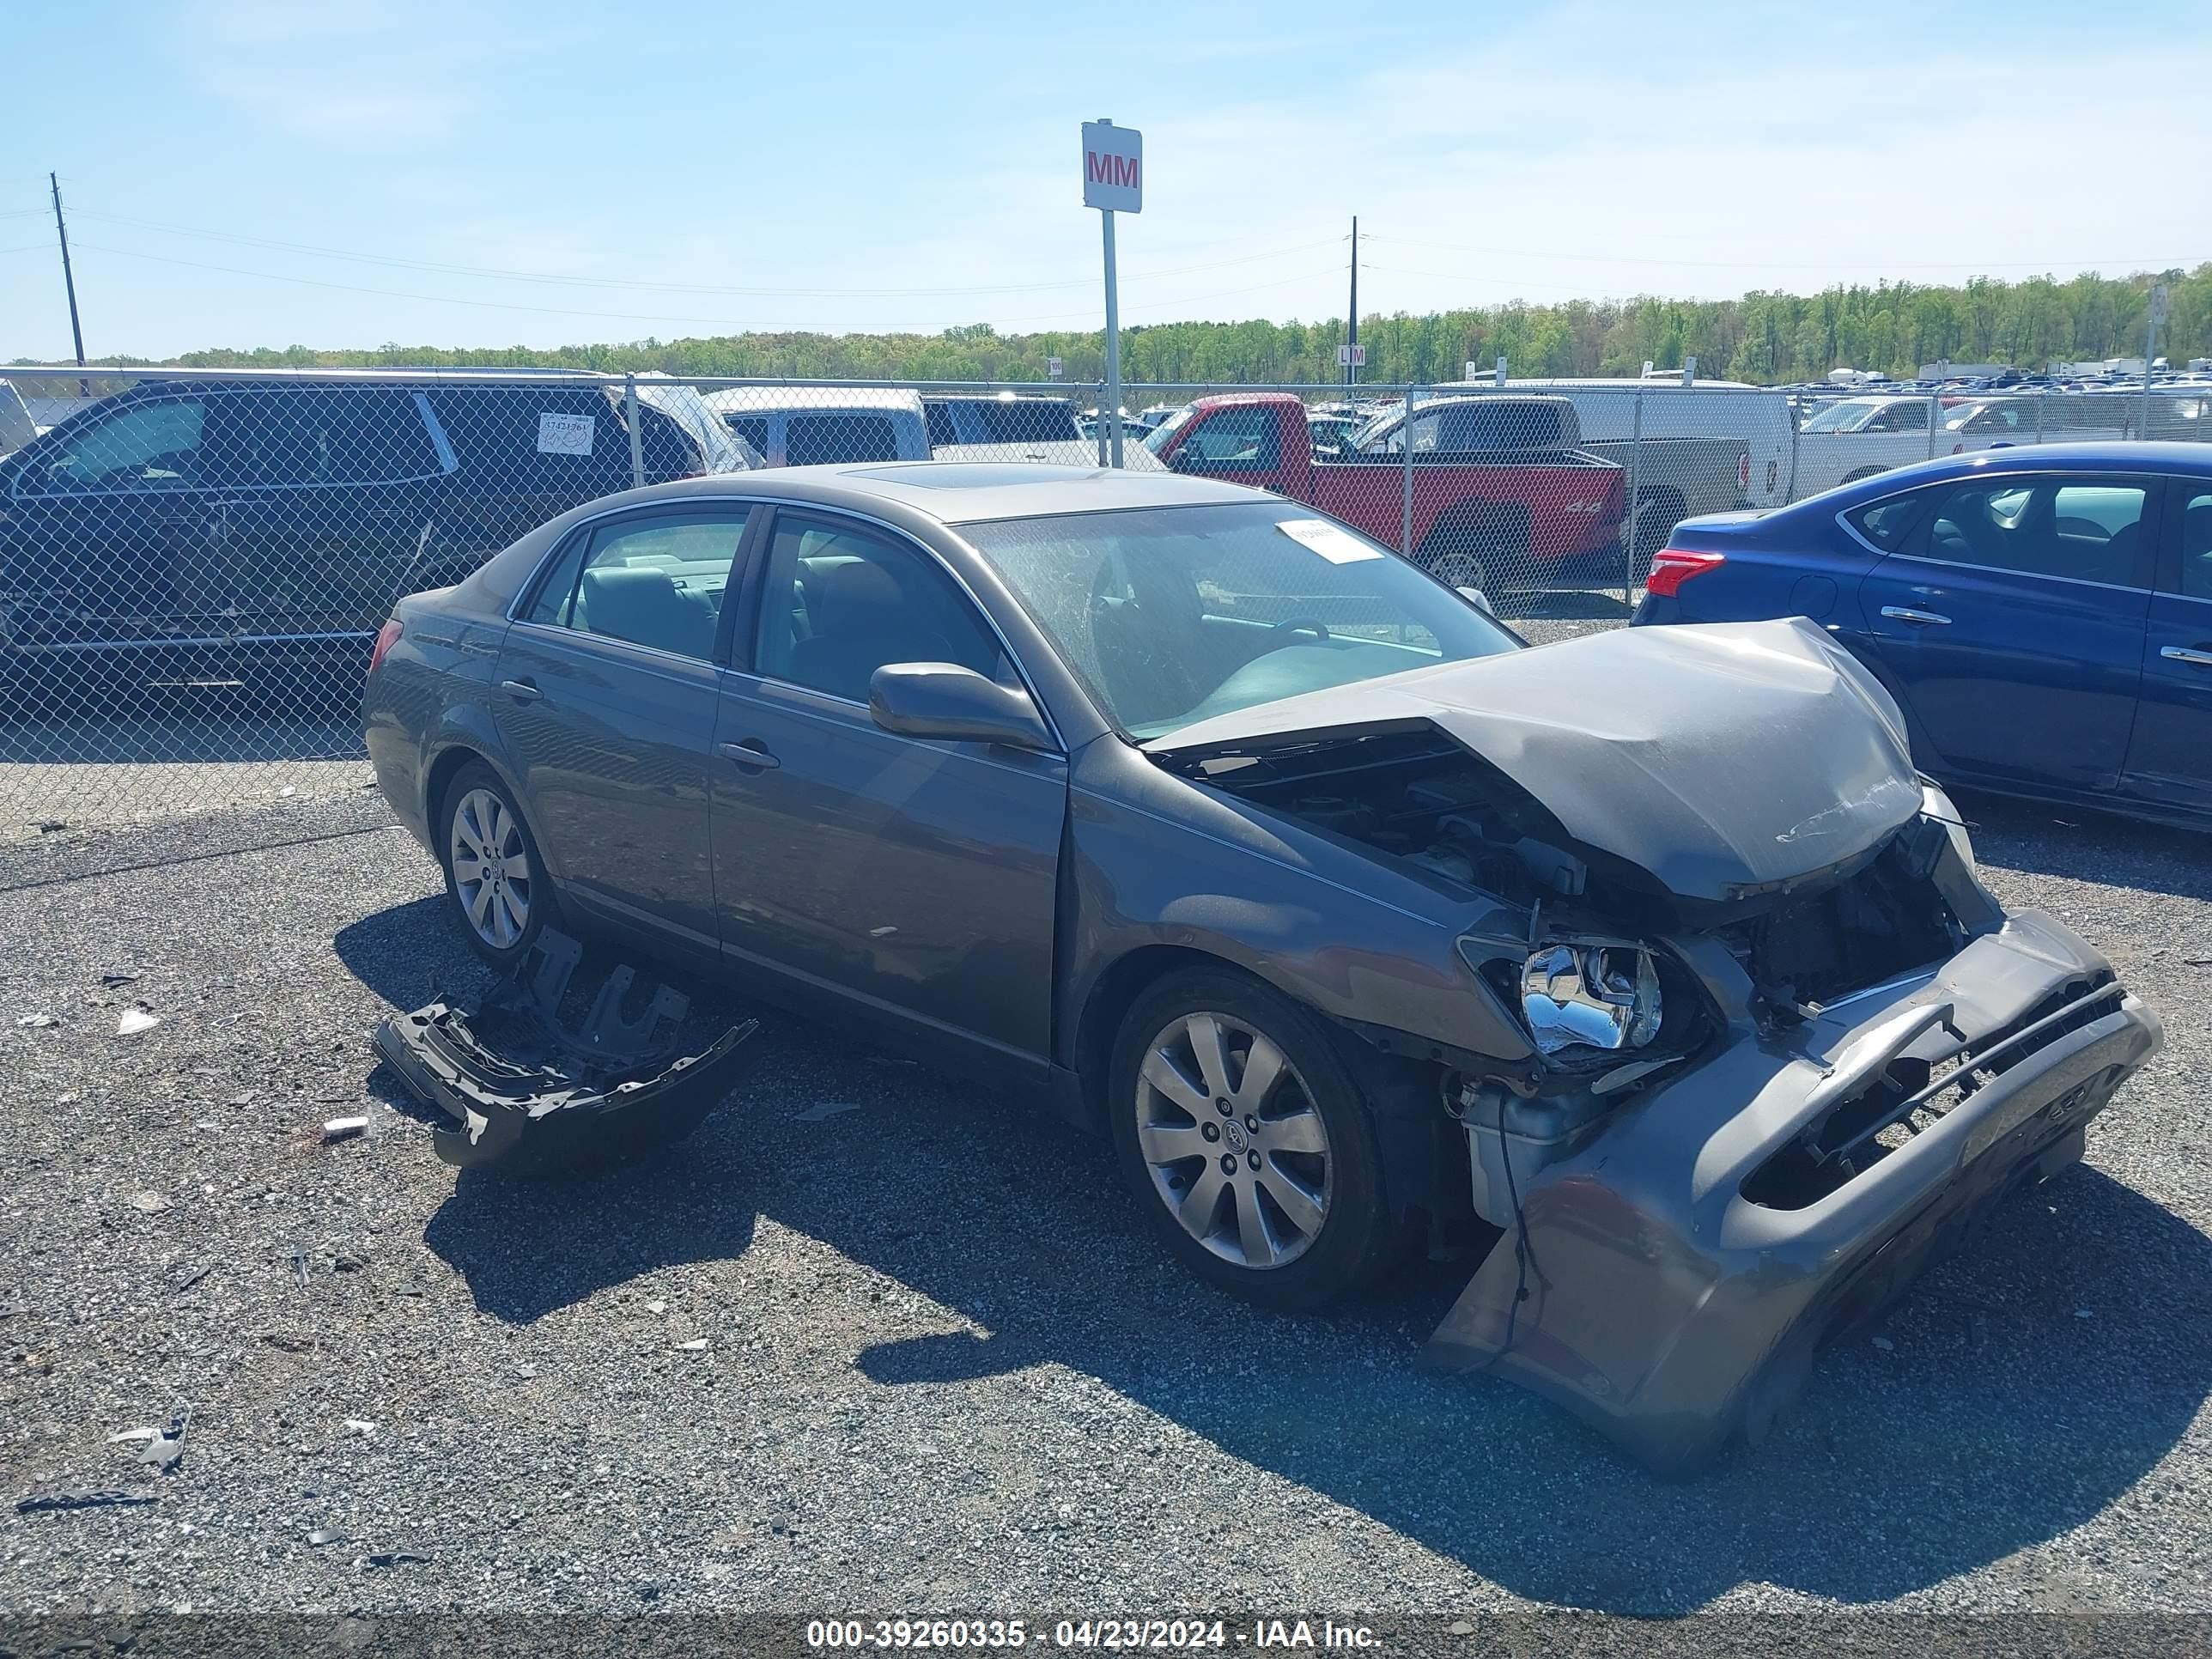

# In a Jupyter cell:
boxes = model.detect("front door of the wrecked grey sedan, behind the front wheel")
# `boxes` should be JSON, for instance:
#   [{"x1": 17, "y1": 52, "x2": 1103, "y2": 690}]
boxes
[{"x1": 712, "y1": 511, "x2": 1066, "y2": 1079}]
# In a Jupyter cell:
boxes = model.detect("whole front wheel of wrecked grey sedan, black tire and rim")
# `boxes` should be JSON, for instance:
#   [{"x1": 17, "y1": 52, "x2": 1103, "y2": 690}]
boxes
[{"x1": 1106, "y1": 969, "x2": 1401, "y2": 1314}]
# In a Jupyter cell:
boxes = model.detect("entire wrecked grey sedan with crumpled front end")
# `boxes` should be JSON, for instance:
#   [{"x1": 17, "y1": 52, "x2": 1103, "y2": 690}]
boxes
[{"x1": 365, "y1": 465, "x2": 2159, "y2": 1467}]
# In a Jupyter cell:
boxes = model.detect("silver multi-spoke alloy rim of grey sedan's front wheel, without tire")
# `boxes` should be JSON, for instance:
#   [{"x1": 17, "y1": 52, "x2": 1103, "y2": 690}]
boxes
[{"x1": 1133, "y1": 1013, "x2": 1334, "y2": 1270}]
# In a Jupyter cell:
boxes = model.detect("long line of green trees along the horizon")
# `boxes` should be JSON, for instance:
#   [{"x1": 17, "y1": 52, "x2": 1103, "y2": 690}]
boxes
[{"x1": 26, "y1": 264, "x2": 2212, "y2": 385}]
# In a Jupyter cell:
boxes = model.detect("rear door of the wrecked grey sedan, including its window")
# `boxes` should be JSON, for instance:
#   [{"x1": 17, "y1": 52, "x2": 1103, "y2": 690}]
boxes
[{"x1": 493, "y1": 507, "x2": 745, "y2": 949}]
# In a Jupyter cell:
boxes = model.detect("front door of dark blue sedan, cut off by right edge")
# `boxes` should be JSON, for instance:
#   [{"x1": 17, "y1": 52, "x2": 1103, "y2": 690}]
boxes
[{"x1": 2121, "y1": 477, "x2": 2212, "y2": 811}]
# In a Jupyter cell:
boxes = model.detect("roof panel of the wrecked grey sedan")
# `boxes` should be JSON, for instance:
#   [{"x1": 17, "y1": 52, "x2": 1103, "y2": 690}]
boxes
[{"x1": 562, "y1": 460, "x2": 1279, "y2": 525}]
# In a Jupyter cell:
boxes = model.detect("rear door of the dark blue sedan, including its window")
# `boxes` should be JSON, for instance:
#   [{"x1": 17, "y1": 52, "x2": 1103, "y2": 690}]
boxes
[{"x1": 1858, "y1": 473, "x2": 2159, "y2": 790}]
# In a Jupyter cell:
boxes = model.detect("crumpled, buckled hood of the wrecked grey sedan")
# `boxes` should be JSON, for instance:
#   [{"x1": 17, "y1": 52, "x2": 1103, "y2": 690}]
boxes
[{"x1": 1144, "y1": 619, "x2": 1920, "y2": 900}]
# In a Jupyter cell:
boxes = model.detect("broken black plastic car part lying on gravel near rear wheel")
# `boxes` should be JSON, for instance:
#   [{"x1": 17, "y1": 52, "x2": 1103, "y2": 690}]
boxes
[{"x1": 374, "y1": 929, "x2": 761, "y2": 1170}]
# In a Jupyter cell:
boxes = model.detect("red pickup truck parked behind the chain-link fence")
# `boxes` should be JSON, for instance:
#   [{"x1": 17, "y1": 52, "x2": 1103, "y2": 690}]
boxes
[{"x1": 1146, "y1": 392, "x2": 1626, "y2": 592}]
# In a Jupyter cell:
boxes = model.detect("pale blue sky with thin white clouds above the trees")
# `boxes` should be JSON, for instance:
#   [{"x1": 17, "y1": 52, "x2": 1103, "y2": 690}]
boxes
[{"x1": 0, "y1": 0, "x2": 2212, "y2": 358}]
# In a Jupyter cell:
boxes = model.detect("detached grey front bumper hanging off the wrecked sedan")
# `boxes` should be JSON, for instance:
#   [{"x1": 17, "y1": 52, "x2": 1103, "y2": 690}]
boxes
[{"x1": 1425, "y1": 911, "x2": 2161, "y2": 1474}]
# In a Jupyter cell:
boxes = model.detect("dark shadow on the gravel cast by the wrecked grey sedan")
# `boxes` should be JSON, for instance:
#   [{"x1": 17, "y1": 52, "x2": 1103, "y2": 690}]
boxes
[{"x1": 341, "y1": 902, "x2": 2212, "y2": 1614}]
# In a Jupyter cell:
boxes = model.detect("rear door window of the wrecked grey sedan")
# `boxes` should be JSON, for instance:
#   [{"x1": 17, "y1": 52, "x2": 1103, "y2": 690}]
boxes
[{"x1": 526, "y1": 514, "x2": 745, "y2": 661}]
